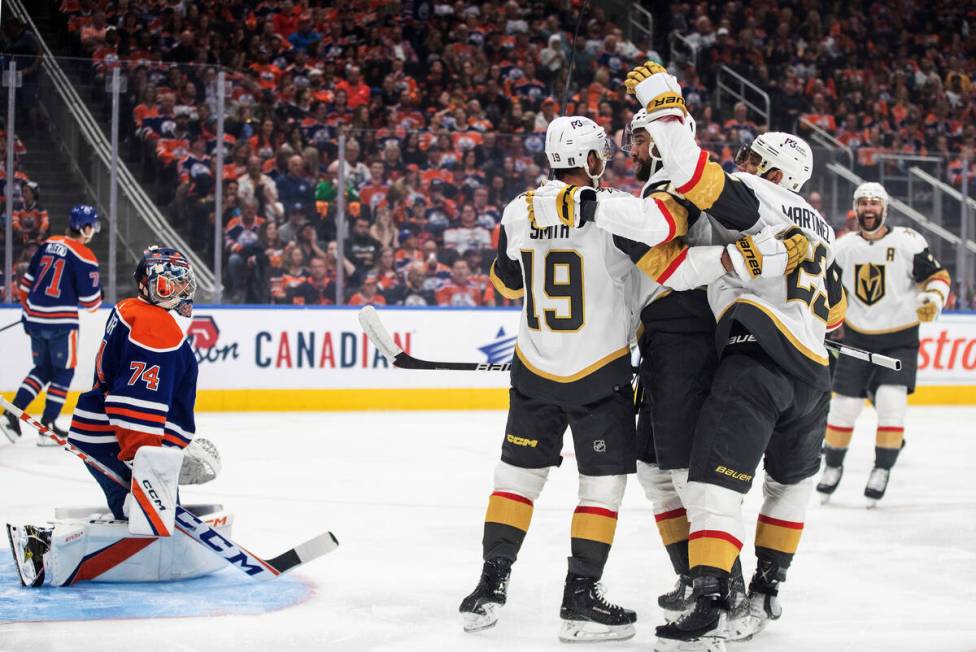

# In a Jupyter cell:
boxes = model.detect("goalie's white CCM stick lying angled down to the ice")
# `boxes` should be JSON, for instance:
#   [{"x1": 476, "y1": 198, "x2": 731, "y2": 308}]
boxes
[{"x1": 0, "y1": 396, "x2": 339, "y2": 579}]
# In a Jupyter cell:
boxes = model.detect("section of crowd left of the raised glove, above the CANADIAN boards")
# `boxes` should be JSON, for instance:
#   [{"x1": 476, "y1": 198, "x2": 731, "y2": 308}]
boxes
[{"x1": 60, "y1": 0, "x2": 664, "y2": 305}]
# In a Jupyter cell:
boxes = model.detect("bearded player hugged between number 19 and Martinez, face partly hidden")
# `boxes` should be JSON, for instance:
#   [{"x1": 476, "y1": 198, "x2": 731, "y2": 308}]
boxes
[{"x1": 614, "y1": 109, "x2": 809, "y2": 620}]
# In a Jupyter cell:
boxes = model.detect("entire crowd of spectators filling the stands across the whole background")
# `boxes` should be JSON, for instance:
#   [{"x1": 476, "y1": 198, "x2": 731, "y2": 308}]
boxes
[{"x1": 1, "y1": 0, "x2": 976, "y2": 305}]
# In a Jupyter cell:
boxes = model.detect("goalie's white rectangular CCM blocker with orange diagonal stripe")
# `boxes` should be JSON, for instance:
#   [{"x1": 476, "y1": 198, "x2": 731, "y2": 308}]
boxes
[{"x1": 129, "y1": 446, "x2": 183, "y2": 537}]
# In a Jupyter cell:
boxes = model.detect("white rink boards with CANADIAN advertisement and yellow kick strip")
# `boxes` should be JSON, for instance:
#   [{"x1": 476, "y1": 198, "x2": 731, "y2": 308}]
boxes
[{"x1": 0, "y1": 306, "x2": 976, "y2": 411}]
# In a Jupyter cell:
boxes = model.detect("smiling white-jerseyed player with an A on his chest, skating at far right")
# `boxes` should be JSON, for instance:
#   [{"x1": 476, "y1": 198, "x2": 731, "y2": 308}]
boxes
[{"x1": 817, "y1": 183, "x2": 950, "y2": 506}]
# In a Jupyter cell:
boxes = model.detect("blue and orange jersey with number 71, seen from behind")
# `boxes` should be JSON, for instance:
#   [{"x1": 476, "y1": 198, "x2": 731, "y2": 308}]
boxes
[{"x1": 20, "y1": 235, "x2": 102, "y2": 332}]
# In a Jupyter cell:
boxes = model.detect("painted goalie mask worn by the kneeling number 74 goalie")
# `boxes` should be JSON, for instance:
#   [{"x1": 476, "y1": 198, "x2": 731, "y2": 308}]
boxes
[{"x1": 135, "y1": 246, "x2": 197, "y2": 317}]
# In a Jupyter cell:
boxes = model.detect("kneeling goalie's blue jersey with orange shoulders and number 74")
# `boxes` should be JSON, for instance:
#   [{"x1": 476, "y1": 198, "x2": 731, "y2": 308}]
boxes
[{"x1": 68, "y1": 298, "x2": 197, "y2": 472}]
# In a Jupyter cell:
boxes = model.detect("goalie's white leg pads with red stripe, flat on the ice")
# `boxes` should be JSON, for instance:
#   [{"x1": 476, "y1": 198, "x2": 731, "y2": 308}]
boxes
[{"x1": 44, "y1": 505, "x2": 234, "y2": 586}]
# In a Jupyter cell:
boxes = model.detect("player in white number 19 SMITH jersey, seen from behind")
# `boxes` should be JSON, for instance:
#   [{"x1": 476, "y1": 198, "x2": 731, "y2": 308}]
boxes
[{"x1": 460, "y1": 116, "x2": 687, "y2": 641}]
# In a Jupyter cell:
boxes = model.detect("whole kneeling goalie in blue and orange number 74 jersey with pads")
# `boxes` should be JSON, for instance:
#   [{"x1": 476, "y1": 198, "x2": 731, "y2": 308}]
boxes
[{"x1": 7, "y1": 247, "x2": 230, "y2": 587}]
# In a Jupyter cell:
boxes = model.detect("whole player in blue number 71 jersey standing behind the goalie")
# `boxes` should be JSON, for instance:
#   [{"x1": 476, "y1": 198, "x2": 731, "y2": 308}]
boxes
[{"x1": 0, "y1": 205, "x2": 102, "y2": 446}]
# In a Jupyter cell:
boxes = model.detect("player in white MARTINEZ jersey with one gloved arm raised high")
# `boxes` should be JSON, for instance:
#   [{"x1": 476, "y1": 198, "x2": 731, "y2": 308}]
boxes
[{"x1": 627, "y1": 62, "x2": 844, "y2": 650}]
